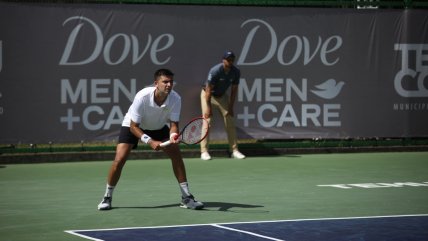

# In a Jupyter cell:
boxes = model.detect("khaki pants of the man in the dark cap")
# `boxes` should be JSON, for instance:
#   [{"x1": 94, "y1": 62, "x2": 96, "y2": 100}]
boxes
[{"x1": 201, "y1": 90, "x2": 238, "y2": 153}]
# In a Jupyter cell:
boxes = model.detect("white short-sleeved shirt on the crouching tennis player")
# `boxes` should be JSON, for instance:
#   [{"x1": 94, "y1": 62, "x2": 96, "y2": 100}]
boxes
[{"x1": 122, "y1": 87, "x2": 181, "y2": 130}]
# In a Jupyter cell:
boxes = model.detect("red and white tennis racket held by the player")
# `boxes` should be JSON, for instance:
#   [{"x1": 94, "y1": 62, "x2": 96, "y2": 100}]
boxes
[{"x1": 160, "y1": 117, "x2": 209, "y2": 147}]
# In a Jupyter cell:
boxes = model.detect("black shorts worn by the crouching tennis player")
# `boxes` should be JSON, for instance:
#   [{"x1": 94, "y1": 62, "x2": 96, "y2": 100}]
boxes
[{"x1": 119, "y1": 125, "x2": 169, "y2": 149}]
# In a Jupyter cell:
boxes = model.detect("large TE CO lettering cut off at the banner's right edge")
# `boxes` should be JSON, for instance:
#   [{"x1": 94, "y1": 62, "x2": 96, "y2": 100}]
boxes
[{"x1": 394, "y1": 44, "x2": 428, "y2": 97}]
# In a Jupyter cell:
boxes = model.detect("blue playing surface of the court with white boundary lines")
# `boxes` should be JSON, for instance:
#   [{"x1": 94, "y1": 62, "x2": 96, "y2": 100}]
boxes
[{"x1": 67, "y1": 214, "x2": 428, "y2": 241}]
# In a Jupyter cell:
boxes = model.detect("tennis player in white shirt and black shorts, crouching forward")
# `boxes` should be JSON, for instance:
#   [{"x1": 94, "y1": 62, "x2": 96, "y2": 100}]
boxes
[{"x1": 98, "y1": 69, "x2": 204, "y2": 210}]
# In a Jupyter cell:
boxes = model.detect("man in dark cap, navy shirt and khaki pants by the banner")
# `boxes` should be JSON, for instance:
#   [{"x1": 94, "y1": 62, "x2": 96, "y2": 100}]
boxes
[{"x1": 201, "y1": 51, "x2": 245, "y2": 160}]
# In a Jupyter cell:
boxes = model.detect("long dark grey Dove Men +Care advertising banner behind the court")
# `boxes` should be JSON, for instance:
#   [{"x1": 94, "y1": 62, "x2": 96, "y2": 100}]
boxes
[{"x1": 0, "y1": 2, "x2": 428, "y2": 143}]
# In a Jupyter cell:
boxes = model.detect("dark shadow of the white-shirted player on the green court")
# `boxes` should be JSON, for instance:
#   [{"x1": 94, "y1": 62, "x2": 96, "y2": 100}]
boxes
[{"x1": 113, "y1": 202, "x2": 268, "y2": 212}]
